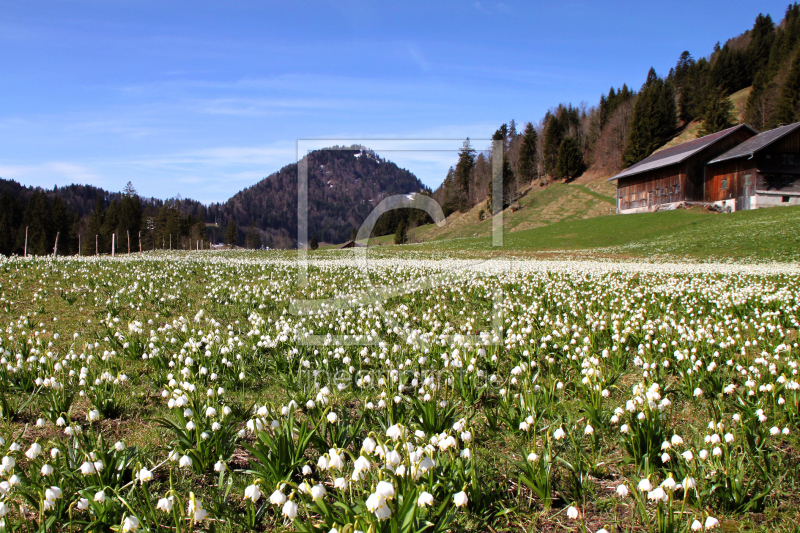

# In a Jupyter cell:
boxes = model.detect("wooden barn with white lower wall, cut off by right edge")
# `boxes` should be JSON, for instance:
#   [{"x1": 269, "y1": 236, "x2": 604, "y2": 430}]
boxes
[{"x1": 705, "y1": 122, "x2": 800, "y2": 211}]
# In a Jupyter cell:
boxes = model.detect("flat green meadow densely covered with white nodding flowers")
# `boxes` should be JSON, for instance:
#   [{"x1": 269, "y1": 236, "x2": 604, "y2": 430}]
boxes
[{"x1": 0, "y1": 250, "x2": 800, "y2": 533}]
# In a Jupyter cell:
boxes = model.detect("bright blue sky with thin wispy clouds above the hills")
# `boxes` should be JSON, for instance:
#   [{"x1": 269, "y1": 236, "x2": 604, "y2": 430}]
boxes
[{"x1": 0, "y1": 0, "x2": 787, "y2": 202}]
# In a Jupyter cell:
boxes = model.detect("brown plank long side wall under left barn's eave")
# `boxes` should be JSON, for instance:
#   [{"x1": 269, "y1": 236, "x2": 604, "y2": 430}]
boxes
[{"x1": 617, "y1": 165, "x2": 686, "y2": 210}]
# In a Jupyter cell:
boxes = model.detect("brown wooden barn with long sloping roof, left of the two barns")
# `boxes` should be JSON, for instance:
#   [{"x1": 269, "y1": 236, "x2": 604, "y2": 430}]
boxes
[{"x1": 609, "y1": 124, "x2": 758, "y2": 213}]
